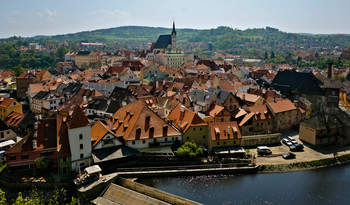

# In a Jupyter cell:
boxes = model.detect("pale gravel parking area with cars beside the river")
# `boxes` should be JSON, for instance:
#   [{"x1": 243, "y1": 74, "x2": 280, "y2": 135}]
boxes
[{"x1": 251, "y1": 130, "x2": 350, "y2": 165}]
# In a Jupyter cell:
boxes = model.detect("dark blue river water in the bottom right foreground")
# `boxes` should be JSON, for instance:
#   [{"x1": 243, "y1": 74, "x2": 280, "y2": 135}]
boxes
[{"x1": 138, "y1": 165, "x2": 350, "y2": 205}]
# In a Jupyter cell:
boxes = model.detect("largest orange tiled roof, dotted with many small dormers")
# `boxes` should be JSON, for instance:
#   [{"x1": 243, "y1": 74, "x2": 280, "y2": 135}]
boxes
[{"x1": 107, "y1": 101, "x2": 181, "y2": 140}]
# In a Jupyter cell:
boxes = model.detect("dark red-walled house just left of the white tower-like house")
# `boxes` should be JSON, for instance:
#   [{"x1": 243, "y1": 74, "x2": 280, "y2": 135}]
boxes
[{"x1": 5, "y1": 117, "x2": 71, "y2": 174}]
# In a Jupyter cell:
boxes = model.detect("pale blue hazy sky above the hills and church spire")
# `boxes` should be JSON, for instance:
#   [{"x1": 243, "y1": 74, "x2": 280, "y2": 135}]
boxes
[{"x1": 0, "y1": 0, "x2": 350, "y2": 38}]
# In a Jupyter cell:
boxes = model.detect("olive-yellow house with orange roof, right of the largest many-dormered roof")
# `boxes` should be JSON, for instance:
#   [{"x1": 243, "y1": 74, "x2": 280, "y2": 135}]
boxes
[{"x1": 167, "y1": 104, "x2": 209, "y2": 146}]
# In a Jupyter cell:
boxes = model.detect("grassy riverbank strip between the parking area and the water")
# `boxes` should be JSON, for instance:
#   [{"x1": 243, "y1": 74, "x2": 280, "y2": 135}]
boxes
[{"x1": 258, "y1": 154, "x2": 350, "y2": 173}]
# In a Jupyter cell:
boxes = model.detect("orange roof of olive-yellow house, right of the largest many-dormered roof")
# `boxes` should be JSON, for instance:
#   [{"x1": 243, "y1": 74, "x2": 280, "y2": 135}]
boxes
[{"x1": 167, "y1": 104, "x2": 207, "y2": 133}]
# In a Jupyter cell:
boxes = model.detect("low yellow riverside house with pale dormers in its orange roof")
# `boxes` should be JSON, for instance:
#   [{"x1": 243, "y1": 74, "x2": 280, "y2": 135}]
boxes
[{"x1": 208, "y1": 121, "x2": 242, "y2": 150}]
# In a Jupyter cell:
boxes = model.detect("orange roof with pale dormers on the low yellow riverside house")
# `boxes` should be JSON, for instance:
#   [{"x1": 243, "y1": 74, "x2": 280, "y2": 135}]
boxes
[{"x1": 209, "y1": 121, "x2": 242, "y2": 141}]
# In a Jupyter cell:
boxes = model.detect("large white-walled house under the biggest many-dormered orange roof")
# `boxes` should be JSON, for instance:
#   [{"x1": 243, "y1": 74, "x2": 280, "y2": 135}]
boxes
[{"x1": 107, "y1": 101, "x2": 181, "y2": 151}]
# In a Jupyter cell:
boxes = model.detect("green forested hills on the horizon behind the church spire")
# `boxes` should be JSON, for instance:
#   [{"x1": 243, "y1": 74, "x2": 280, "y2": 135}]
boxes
[{"x1": 0, "y1": 26, "x2": 350, "y2": 56}]
